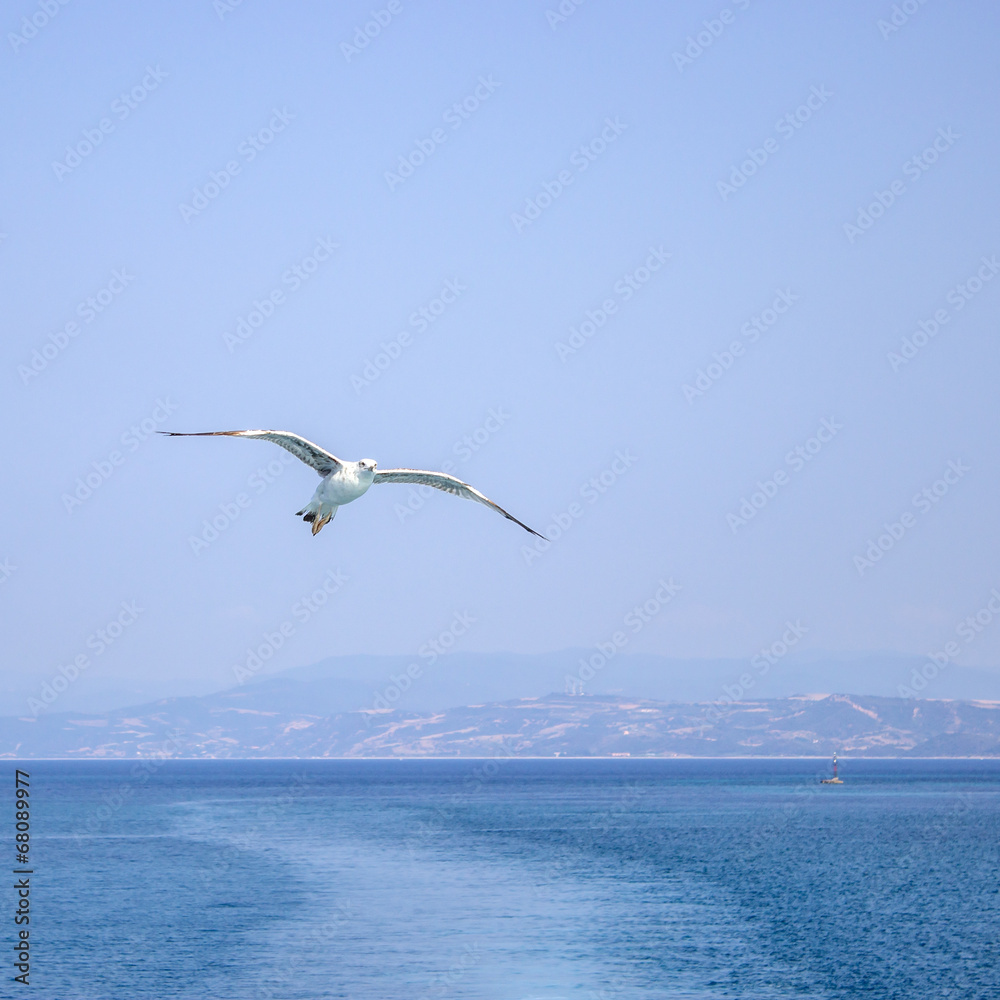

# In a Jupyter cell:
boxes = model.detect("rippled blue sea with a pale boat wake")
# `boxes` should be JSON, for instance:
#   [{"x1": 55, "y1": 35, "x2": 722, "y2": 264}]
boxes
[{"x1": 9, "y1": 758, "x2": 1000, "y2": 1000}]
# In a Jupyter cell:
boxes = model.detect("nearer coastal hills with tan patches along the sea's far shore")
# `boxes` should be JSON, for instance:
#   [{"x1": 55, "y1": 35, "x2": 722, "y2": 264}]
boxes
[{"x1": 0, "y1": 684, "x2": 1000, "y2": 758}]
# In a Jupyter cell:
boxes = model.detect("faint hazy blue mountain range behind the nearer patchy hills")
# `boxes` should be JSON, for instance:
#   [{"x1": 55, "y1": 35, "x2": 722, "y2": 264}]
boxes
[{"x1": 9, "y1": 649, "x2": 1000, "y2": 715}]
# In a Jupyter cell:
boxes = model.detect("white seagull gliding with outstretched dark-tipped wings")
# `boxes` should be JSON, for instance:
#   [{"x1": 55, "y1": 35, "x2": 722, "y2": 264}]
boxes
[{"x1": 159, "y1": 431, "x2": 545, "y2": 539}]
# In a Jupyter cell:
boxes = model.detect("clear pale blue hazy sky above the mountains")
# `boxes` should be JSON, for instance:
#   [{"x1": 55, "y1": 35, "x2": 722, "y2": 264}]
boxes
[{"x1": 0, "y1": 0, "x2": 1000, "y2": 712}]
